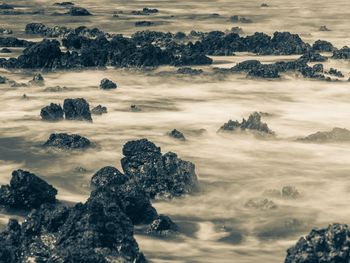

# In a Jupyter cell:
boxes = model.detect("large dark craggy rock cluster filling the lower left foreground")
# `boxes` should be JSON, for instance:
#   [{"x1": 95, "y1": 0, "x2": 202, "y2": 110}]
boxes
[{"x1": 0, "y1": 139, "x2": 197, "y2": 263}]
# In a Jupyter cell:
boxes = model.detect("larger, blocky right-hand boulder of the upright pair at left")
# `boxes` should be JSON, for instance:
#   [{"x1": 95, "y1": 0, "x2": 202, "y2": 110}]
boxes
[{"x1": 63, "y1": 98, "x2": 92, "y2": 122}]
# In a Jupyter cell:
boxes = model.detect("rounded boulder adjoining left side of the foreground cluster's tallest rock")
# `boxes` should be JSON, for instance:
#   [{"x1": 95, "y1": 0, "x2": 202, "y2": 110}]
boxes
[{"x1": 91, "y1": 166, "x2": 129, "y2": 189}]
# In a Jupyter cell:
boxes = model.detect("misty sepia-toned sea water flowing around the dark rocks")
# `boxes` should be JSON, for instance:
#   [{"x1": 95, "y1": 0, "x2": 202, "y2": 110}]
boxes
[{"x1": 0, "y1": 0, "x2": 350, "y2": 263}]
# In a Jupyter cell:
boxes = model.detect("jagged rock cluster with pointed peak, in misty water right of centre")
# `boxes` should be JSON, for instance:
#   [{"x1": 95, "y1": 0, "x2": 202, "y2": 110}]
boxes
[{"x1": 219, "y1": 112, "x2": 274, "y2": 135}]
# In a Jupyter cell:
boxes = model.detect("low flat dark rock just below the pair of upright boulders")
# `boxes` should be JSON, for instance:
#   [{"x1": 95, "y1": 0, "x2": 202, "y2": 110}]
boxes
[{"x1": 43, "y1": 133, "x2": 92, "y2": 150}]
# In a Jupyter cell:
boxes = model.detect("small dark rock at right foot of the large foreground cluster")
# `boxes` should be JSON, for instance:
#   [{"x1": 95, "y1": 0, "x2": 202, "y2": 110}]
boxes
[{"x1": 147, "y1": 215, "x2": 178, "y2": 236}]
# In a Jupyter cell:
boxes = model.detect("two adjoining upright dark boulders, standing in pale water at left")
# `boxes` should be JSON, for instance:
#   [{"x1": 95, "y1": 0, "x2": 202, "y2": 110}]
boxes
[{"x1": 40, "y1": 98, "x2": 92, "y2": 122}]
